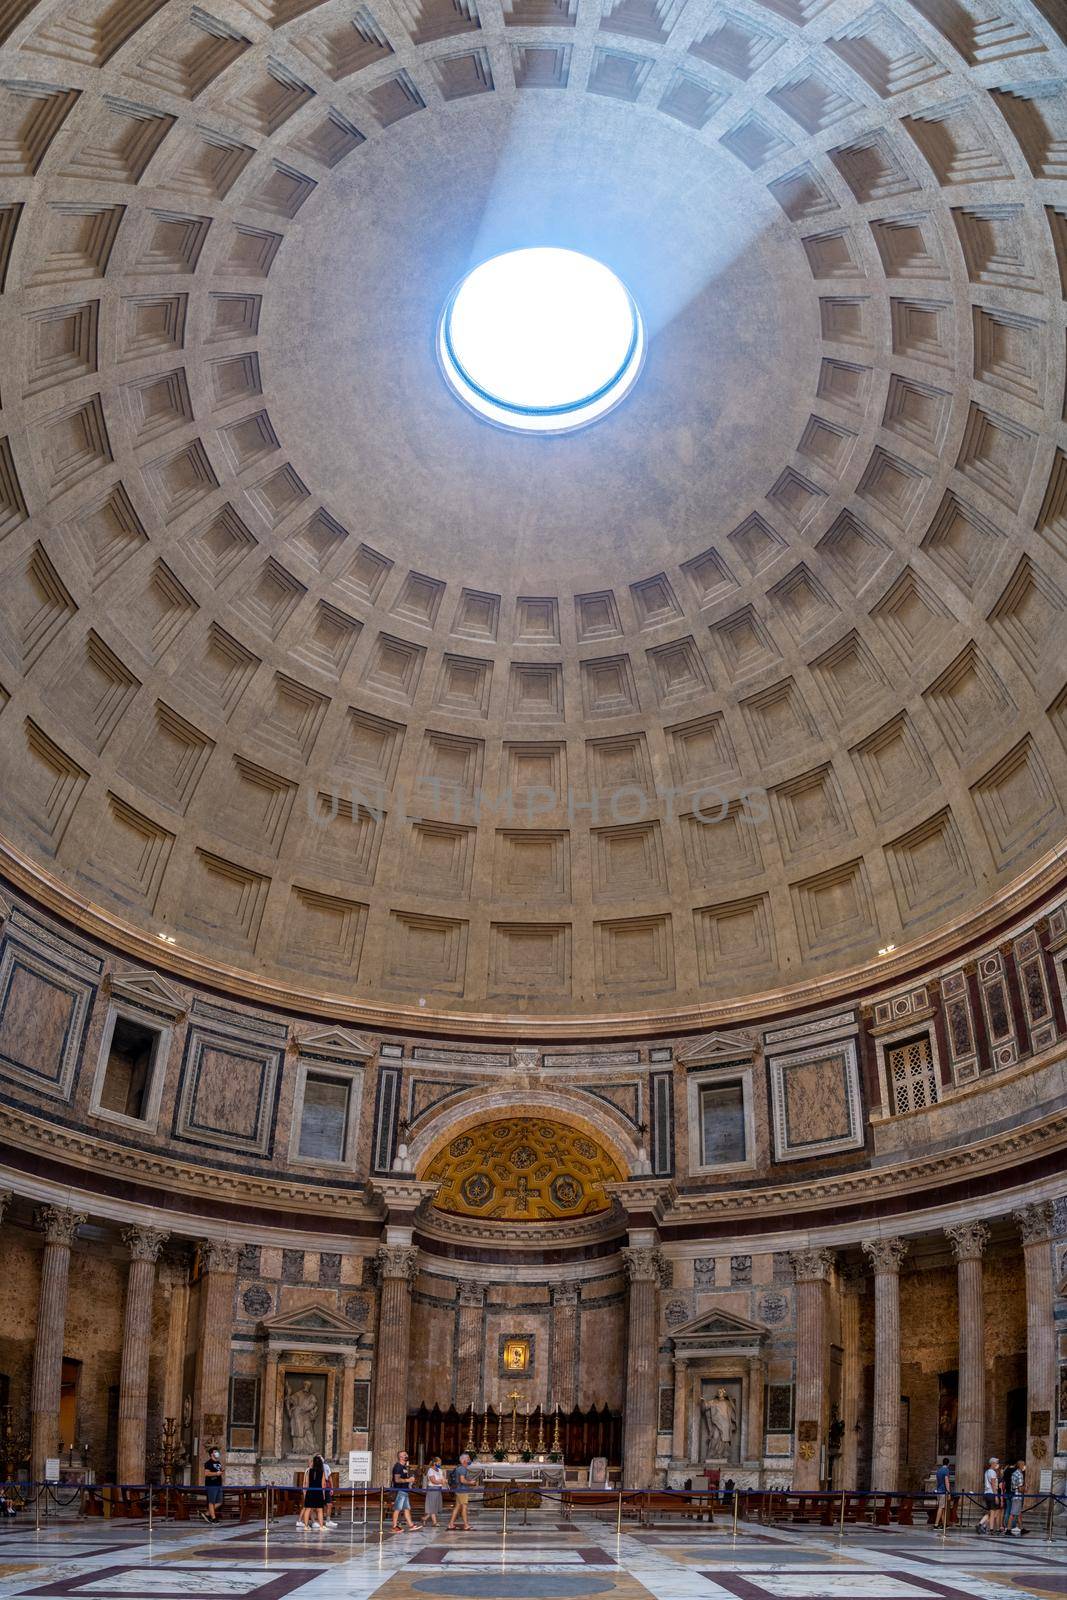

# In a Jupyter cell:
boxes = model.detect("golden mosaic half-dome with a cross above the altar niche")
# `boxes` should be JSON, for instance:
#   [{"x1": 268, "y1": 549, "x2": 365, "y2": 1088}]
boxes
[{"x1": 424, "y1": 1117, "x2": 622, "y2": 1222}]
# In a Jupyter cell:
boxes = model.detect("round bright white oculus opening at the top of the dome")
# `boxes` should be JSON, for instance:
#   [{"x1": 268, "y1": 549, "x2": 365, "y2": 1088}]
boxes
[{"x1": 437, "y1": 248, "x2": 646, "y2": 434}]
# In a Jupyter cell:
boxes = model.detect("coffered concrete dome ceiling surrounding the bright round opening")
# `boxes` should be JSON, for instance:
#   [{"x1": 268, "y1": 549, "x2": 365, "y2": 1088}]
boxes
[{"x1": 0, "y1": 0, "x2": 1067, "y2": 1034}]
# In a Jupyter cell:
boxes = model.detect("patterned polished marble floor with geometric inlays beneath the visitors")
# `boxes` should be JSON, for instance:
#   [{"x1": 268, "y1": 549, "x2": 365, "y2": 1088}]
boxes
[{"x1": 0, "y1": 1510, "x2": 1067, "y2": 1600}]
